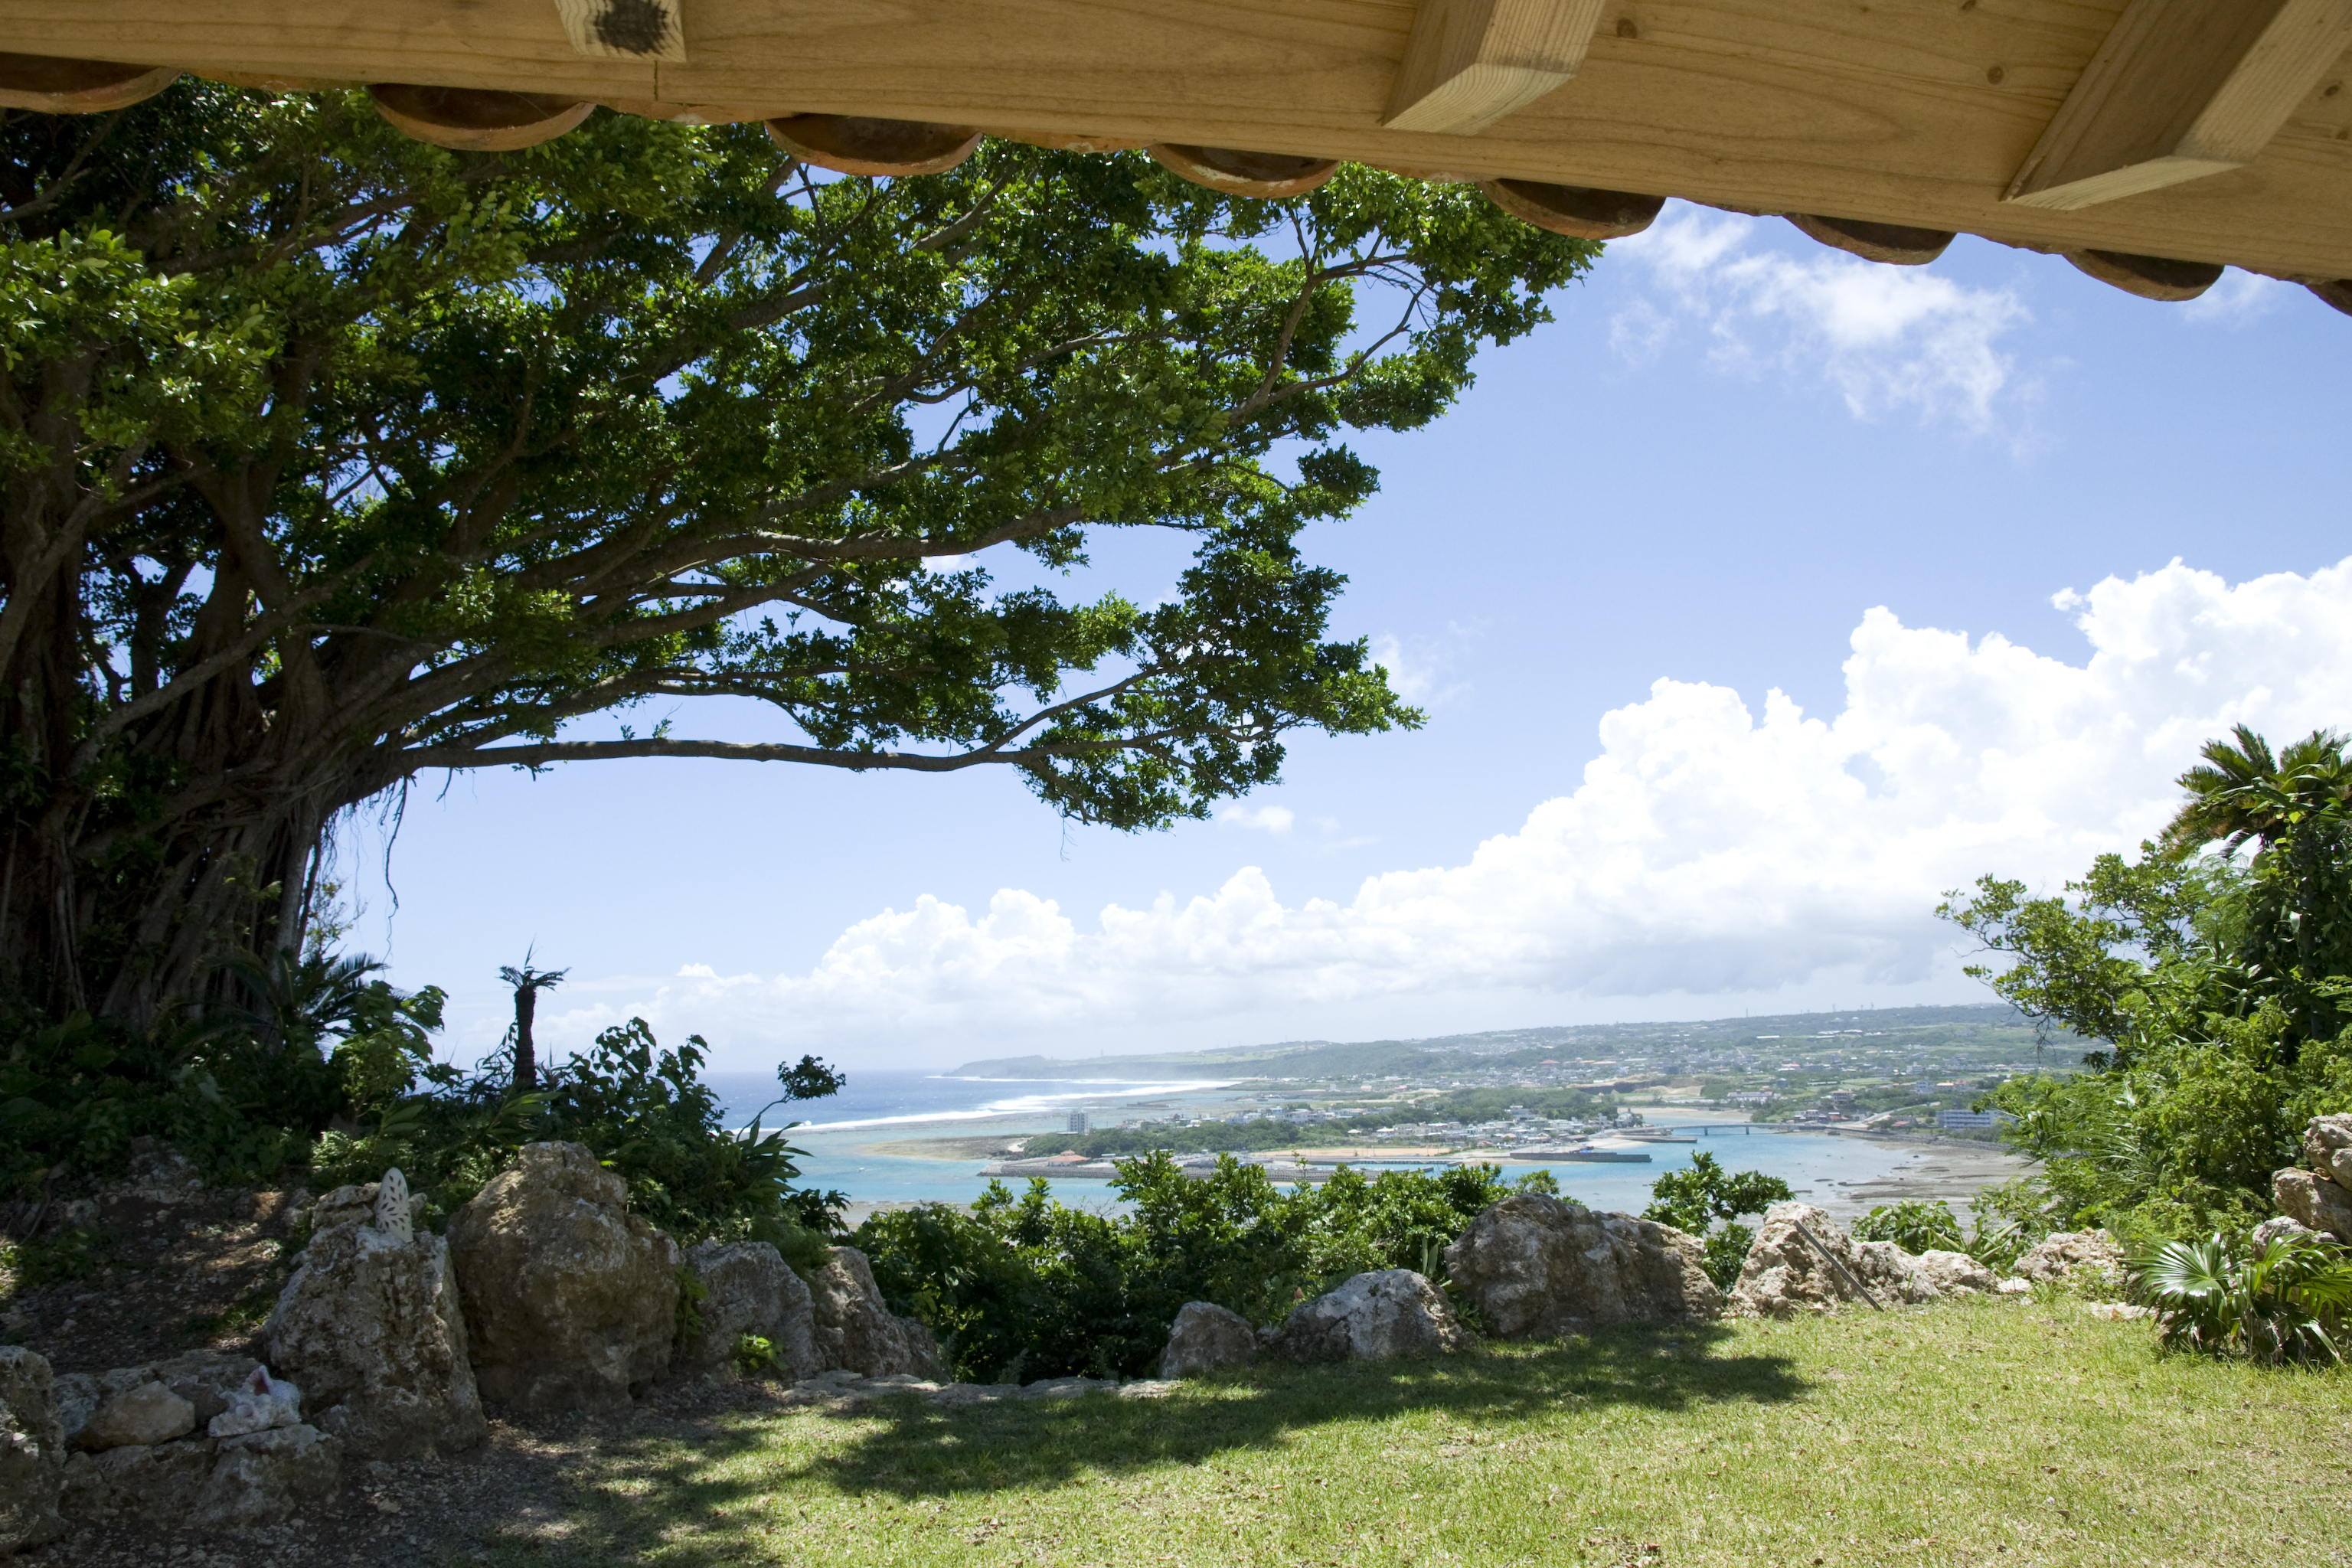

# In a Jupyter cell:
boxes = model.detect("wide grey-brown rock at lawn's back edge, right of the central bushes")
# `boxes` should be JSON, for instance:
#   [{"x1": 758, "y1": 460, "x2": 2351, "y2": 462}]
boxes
[{"x1": 1446, "y1": 1192, "x2": 1724, "y2": 1340}]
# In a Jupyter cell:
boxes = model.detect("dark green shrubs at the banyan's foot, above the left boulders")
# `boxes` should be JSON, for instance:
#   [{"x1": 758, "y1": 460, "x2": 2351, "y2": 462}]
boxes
[{"x1": 0, "y1": 930, "x2": 844, "y2": 1263}]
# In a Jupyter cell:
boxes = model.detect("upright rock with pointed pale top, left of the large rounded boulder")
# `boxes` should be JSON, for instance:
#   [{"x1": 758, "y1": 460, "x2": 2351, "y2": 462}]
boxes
[{"x1": 266, "y1": 1171, "x2": 489, "y2": 1460}]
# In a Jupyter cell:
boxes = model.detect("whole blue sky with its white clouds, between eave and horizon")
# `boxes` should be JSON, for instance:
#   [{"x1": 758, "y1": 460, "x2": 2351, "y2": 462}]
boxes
[{"x1": 344, "y1": 204, "x2": 2352, "y2": 1070}]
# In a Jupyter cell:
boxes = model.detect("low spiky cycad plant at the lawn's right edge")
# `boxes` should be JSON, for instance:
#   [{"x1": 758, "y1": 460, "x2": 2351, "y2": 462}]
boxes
[{"x1": 2131, "y1": 1234, "x2": 2352, "y2": 1364}]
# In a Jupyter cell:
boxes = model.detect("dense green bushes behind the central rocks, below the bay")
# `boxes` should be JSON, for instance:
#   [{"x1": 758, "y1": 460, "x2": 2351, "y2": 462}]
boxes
[{"x1": 851, "y1": 1155, "x2": 1555, "y2": 1382}]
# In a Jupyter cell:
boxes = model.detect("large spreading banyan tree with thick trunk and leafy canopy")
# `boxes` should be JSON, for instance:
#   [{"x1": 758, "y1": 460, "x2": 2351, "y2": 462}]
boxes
[{"x1": 0, "y1": 82, "x2": 1597, "y2": 1023}]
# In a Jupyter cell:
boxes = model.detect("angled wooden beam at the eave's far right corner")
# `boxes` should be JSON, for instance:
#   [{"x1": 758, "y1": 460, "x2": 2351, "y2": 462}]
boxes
[{"x1": 2006, "y1": 0, "x2": 2352, "y2": 211}]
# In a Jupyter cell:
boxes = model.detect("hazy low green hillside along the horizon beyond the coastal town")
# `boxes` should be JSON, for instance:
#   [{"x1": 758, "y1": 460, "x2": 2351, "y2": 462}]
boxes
[{"x1": 955, "y1": 1001, "x2": 2032, "y2": 1079}]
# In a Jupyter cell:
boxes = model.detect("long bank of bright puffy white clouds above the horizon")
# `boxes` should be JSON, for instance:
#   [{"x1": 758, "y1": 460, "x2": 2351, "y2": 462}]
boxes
[{"x1": 541, "y1": 560, "x2": 2352, "y2": 1067}]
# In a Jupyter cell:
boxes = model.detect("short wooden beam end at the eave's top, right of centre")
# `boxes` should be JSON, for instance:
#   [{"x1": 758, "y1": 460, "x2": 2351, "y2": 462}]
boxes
[{"x1": 1380, "y1": 0, "x2": 1632, "y2": 136}]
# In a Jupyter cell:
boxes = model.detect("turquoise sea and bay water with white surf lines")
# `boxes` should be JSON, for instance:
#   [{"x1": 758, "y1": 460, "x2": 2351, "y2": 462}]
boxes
[{"x1": 710, "y1": 1072, "x2": 1966, "y2": 1215}]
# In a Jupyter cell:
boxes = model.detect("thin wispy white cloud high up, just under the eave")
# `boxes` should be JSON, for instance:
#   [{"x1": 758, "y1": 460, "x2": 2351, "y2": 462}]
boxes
[{"x1": 1609, "y1": 202, "x2": 2034, "y2": 430}]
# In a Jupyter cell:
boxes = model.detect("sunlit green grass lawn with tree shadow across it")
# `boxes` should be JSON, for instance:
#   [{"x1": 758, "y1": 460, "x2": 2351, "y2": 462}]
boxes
[{"x1": 475, "y1": 1300, "x2": 2352, "y2": 1566}]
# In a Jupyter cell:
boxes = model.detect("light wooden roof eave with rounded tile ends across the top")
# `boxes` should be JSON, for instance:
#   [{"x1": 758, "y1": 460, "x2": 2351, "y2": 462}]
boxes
[{"x1": 0, "y1": 0, "x2": 2352, "y2": 303}]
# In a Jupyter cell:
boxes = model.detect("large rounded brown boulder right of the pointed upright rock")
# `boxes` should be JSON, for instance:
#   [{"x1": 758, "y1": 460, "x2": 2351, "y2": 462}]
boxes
[{"x1": 449, "y1": 1142, "x2": 680, "y2": 1410}]
